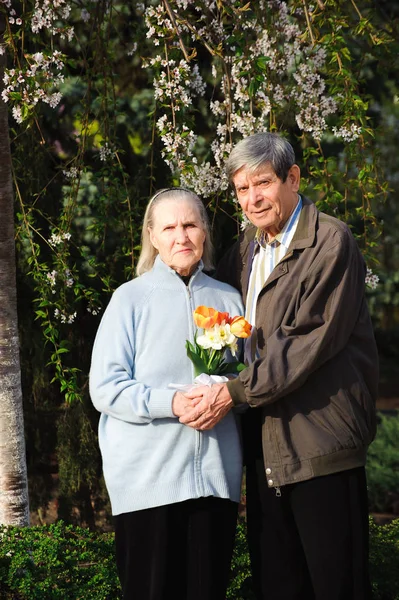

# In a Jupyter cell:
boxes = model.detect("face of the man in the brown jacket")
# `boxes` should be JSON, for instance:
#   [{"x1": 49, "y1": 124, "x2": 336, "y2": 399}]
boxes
[{"x1": 233, "y1": 163, "x2": 300, "y2": 239}]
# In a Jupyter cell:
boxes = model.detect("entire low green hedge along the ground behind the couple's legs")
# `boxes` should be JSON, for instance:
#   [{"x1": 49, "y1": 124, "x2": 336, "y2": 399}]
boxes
[{"x1": 0, "y1": 518, "x2": 399, "y2": 600}]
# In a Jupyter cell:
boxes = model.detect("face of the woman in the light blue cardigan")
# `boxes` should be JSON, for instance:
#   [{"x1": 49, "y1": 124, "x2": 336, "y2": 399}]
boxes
[{"x1": 149, "y1": 200, "x2": 205, "y2": 275}]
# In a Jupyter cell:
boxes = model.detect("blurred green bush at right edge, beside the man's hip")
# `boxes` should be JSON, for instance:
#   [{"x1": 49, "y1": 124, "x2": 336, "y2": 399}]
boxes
[{"x1": 366, "y1": 413, "x2": 399, "y2": 513}]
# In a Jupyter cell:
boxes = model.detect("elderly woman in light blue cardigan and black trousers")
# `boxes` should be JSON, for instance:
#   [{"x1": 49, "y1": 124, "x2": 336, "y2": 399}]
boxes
[{"x1": 90, "y1": 188, "x2": 243, "y2": 600}]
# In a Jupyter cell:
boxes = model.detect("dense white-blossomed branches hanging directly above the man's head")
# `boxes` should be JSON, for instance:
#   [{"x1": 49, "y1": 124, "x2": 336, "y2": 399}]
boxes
[{"x1": 145, "y1": 0, "x2": 389, "y2": 247}]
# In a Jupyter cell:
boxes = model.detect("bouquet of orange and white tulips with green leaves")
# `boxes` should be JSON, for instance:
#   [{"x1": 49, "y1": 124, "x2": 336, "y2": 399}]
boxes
[{"x1": 186, "y1": 306, "x2": 252, "y2": 376}]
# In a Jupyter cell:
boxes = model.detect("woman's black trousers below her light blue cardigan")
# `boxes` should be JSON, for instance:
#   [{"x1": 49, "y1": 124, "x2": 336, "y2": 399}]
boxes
[{"x1": 114, "y1": 497, "x2": 238, "y2": 600}]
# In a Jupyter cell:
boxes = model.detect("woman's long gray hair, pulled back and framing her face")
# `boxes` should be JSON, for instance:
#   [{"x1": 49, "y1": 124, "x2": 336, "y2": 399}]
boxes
[{"x1": 136, "y1": 187, "x2": 213, "y2": 275}]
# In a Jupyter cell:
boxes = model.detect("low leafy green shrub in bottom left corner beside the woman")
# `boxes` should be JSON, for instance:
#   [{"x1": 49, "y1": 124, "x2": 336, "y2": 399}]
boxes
[{"x1": 0, "y1": 521, "x2": 121, "y2": 600}]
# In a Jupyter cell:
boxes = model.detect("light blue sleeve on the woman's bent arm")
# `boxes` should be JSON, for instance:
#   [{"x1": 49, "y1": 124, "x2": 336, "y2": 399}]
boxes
[{"x1": 89, "y1": 292, "x2": 177, "y2": 423}]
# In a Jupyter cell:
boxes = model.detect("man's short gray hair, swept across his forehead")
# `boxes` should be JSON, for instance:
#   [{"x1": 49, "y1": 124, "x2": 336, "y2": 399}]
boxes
[{"x1": 226, "y1": 133, "x2": 295, "y2": 183}]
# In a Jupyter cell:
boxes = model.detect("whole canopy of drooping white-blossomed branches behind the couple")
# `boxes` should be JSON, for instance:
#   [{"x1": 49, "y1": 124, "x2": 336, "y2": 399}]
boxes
[{"x1": 0, "y1": 0, "x2": 394, "y2": 516}]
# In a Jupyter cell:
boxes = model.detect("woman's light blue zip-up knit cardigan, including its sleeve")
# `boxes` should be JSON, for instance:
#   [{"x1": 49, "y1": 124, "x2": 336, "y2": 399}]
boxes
[{"x1": 90, "y1": 257, "x2": 243, "y2": 515}]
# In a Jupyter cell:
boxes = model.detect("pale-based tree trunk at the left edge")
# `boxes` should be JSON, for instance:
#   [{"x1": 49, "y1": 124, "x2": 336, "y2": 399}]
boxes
[{"x1": 0, "y1": 15, "x2": 29, "y2": 526}]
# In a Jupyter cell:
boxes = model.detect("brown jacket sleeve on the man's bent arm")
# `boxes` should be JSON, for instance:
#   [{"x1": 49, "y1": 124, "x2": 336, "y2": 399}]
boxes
[{"x1": 227, "y1": 229, "x2": 365, "y2": 406}]
